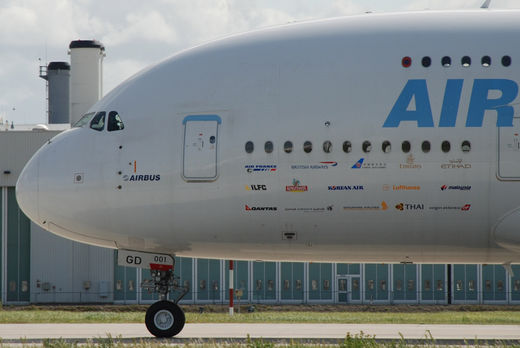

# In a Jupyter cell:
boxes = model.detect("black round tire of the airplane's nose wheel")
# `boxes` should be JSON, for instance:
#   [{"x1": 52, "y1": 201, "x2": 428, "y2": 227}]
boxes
[{"x1": 145, "y1": 301, "x2": 186, "y2": 337}]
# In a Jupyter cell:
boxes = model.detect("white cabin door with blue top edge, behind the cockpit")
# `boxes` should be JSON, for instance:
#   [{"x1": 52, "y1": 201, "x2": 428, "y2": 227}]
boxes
[{"x1": 182, "y1": 115, "x2": 222, "y2": 181}]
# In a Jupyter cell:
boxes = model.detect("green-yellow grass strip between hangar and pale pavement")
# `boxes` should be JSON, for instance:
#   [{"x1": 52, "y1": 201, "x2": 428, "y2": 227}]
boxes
[{"x1": 0, "y1": 310, "x2": 520, "y2": 325}]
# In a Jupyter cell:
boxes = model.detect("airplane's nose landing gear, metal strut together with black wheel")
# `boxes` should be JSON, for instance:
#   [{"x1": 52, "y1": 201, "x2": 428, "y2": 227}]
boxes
[{"x1": 141, "y1": 267, "x2": 189, "y2": 337}]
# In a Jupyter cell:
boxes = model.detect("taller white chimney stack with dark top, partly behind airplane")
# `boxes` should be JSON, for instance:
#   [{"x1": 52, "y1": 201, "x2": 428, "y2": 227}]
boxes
[{"x1": 69, "y1": 40, "x2": 105, "y2": 125}]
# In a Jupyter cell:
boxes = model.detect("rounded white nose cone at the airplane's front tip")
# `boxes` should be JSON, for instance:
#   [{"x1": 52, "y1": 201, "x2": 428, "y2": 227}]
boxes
[{"x1": 16, "y1": 156, "x2": 39, "y2": 222}]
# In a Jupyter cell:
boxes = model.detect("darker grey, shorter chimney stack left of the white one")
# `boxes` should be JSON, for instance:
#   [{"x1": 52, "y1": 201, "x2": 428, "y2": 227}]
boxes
[{"x1": 40, "y1": 62, "x2": 70, "y2": 124}]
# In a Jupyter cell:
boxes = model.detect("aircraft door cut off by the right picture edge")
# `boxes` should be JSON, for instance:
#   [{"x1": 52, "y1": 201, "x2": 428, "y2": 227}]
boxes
[{"x1": 497, "y1": 117, "x2": 520, "y2": 180}]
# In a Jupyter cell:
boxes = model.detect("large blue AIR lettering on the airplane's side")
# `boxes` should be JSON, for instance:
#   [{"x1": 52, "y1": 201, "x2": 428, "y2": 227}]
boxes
[{"x1": 383, "y1": 79, "x2": 518, "y2": 127}]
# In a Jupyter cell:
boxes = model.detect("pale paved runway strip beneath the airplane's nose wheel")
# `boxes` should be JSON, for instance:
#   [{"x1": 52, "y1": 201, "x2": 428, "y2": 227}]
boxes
[{"x1": 0, "y1": 324, "x2": 520, "y2": 343}]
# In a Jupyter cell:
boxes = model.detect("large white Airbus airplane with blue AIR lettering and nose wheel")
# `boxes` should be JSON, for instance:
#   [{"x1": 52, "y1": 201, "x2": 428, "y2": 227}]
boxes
[{"x1": 16, "y1": 10, "x2": 520, "y2": 337}]
